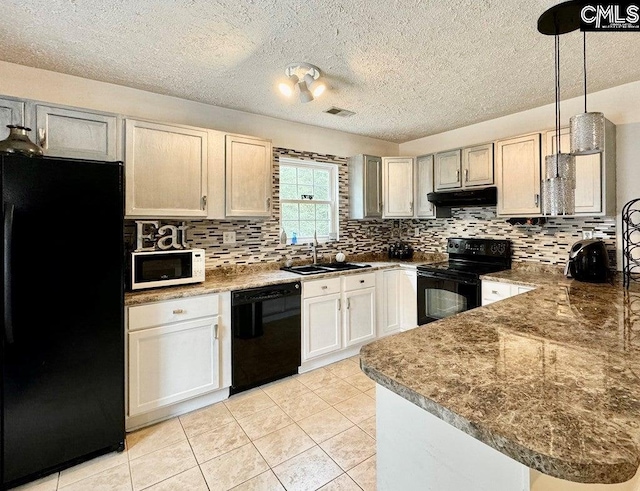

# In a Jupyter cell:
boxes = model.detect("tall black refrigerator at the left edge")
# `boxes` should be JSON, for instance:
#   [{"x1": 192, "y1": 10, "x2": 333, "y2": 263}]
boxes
[{"x1": 0, "y1": 156, "x2": 125, "y2": 489}]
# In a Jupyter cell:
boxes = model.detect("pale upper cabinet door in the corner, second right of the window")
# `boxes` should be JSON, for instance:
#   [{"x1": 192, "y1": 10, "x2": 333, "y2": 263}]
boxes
[{"x1": 382, "y1": 157, "x2": 414, "y2": 218}]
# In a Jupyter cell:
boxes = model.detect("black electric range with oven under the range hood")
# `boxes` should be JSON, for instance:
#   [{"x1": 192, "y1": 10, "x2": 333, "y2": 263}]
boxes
[{"x1": 417, "y1": 238, "x2": 511, "y2": 325}]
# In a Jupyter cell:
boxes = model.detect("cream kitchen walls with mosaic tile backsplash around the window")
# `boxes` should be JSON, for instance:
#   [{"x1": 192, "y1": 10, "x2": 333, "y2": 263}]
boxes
[{"x1": 0, "y1": 61, "x2": 640, "y2": 267}]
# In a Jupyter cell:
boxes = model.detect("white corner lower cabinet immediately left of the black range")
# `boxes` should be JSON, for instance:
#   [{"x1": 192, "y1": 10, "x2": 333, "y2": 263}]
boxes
[{"x1": 378, "y1": 268, "x2": 418, "y2": 337}]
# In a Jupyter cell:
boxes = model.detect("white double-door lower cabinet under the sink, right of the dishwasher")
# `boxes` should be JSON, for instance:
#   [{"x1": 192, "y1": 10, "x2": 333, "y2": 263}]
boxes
[{"x1": 302, "y1": 273, "x2": 376, "y2": 362}]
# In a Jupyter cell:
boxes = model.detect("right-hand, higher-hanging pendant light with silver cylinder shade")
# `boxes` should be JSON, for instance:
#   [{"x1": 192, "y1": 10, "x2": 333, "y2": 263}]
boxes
[{"x1": 569, "y1": 32, "x2": 604, "y2": 155}]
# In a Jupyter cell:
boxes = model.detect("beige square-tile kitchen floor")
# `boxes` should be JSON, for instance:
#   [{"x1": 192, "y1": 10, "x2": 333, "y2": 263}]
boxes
[{"x1": 15, "y1": 356, "x2": 376, "y2": 491}]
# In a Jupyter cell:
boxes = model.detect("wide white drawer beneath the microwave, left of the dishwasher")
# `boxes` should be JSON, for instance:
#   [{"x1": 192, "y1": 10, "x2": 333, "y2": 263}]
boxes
[{"x1": 128, "y1": 294, "x2": 219, "y2": 331}]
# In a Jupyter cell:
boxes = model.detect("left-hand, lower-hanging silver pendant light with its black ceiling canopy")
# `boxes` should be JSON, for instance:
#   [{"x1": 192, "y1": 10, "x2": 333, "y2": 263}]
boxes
[{"x1": 538, "y1": 2, "x2": 577, "y2": 216}]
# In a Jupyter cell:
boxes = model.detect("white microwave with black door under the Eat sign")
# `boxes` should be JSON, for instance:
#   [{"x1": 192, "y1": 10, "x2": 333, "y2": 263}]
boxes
[{"x1": 130, "y1": 249, "x2": 204, "y2": 290}]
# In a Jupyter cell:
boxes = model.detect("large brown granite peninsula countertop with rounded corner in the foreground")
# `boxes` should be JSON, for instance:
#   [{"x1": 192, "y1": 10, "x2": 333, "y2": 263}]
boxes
[{"x1": 361, "y1": 274, "x2": 640, "y2": 484}]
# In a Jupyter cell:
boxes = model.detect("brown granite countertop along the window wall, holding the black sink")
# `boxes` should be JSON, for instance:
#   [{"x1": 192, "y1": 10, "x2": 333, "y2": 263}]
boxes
[{"x1": 124, "y1": 253, "x2": 446, "y2": 306}]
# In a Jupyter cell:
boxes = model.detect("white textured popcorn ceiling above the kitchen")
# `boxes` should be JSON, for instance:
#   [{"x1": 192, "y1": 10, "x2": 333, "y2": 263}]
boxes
[{"x1": 0, "y1": 0, "x2": 640, "y2": 143}]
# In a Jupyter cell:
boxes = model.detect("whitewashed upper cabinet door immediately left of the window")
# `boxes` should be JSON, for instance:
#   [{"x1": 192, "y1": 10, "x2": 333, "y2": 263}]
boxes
[{"x1": 225, "y1": 135, "x2": 273, "y2": 217}]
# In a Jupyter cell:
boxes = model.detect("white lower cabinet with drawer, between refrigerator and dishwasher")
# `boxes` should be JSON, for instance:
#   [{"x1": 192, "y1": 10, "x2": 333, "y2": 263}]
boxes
[{"x1": 127, "y1": 294, "x2": 230, "y2": 417}]
